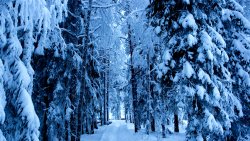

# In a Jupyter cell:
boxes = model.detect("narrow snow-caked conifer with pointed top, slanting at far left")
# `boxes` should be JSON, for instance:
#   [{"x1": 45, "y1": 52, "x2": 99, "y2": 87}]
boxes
[{"x1": 3, "y1": 13, "x2": 40, "y2": 140}]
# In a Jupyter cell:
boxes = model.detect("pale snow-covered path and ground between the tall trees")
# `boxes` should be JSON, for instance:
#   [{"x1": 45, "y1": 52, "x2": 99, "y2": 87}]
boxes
[{"x1": 81, "y1": 120, "x2": 185, "y2": 141}]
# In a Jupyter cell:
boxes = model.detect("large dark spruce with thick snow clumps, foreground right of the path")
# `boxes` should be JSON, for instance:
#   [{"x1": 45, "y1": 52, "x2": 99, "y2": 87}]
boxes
[{"x1": 148, "y1": 0, "x2": 242, "y2": 140}]
